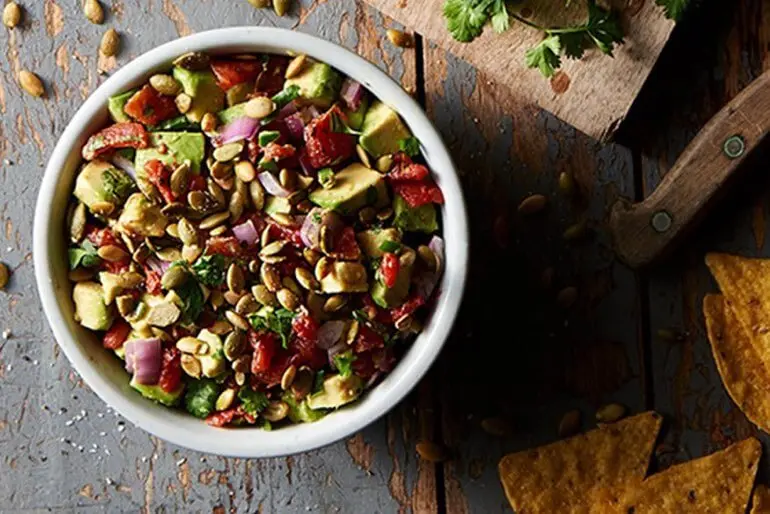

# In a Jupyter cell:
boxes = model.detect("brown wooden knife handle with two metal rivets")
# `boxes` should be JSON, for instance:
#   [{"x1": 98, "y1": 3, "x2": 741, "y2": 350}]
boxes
[{"x1": 610, "y1": 71, "x2": 770, "y2": 268}]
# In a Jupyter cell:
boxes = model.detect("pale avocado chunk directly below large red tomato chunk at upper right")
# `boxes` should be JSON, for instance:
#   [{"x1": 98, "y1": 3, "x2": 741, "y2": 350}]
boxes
[{"x1": 309, "y1": 163, "x2": 389, "y2": 214}]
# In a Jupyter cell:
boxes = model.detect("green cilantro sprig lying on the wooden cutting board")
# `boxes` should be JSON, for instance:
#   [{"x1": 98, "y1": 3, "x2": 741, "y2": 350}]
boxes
[{"x1": 444, "y1": 0, "x2": 691, "y2": 78}]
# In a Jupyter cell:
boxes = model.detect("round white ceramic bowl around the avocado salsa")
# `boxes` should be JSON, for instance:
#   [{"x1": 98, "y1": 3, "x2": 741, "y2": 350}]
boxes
[{"x1": 34, "y1": 27, "x2": 468, "y2": 457}]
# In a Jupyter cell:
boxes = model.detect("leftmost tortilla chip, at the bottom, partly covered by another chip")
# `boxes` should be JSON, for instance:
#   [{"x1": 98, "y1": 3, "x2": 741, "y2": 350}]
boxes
[{"x1": 498, "y1": 412, "x2": 662, "y2": 514}]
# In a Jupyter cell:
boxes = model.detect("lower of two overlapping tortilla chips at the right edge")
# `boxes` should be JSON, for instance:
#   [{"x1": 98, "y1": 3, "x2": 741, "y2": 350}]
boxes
[{"x1": 703, "y1": 295, "x2": 770, "y2": 433}]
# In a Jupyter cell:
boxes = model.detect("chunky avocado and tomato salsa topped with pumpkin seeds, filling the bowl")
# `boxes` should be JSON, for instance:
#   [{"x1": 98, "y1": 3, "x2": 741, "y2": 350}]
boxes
[{"x1": 67, "y1": 52, "x2": 444, "y2": 429}]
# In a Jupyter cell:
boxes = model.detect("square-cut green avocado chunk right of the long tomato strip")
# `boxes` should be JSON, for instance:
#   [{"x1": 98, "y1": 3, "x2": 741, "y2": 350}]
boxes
[{"x1": 134, "y1": 132, "x2": 206, "y2": 176}]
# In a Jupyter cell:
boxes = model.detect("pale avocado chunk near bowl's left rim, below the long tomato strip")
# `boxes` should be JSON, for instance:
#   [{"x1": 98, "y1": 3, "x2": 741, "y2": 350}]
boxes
[{"x1": 73, "y1": 160, "x2": 134, "y2": 211}]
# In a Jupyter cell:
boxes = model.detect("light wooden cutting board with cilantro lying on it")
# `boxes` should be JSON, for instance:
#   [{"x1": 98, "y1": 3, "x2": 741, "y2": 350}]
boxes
[{"x1": 365, "y1": 0, "x2": 674, "y2": 141}]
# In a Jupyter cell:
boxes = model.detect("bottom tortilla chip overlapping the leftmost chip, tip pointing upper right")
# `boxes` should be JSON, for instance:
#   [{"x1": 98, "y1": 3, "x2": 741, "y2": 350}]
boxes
[{"x1": 591, "y1": 437, "x2": 762, "y2": 514}]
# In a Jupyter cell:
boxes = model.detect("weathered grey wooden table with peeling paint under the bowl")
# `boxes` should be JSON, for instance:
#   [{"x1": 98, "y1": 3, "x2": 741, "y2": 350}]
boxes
[{"x1": 0, "y1": 0, "x2": 770, "y2": 514}]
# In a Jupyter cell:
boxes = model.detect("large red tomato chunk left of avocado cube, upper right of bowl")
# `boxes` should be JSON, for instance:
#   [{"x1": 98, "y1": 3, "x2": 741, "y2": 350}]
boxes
[{"x1": 305, "y1": 105, "x2": 356, "y2": 169}]
